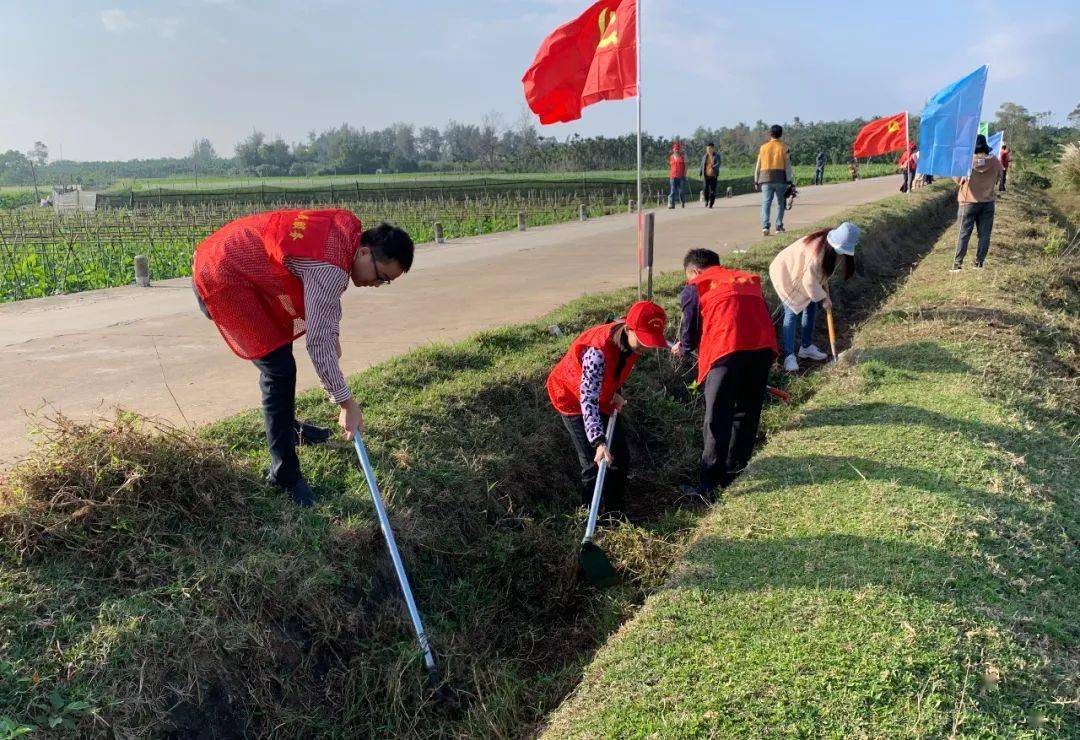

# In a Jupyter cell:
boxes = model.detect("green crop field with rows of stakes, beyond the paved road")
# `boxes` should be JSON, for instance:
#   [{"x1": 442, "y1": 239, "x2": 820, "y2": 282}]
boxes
[{"x1": 0, "y1": 165, "x2": 887, "y2": 302}]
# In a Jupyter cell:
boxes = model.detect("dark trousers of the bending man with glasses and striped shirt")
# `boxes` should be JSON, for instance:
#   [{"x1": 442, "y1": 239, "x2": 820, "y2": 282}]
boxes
[{"x1": 191, "y1": 285, "x2": 300, "y2": 487}]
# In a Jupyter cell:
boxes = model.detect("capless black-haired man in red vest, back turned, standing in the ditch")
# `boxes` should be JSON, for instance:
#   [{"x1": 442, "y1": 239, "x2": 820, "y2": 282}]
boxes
[{"x1": 672, "y1": 250, "x2": 779, "y2": 500}]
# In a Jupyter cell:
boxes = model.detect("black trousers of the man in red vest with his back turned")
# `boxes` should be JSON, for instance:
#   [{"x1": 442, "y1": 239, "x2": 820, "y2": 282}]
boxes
[{"x1": 698, "y1": 349, "x2": 773, "y2": 493}]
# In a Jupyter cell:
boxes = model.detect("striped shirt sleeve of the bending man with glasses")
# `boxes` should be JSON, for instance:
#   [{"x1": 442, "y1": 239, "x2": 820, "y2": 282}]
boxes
[{"x1": 285, "y1": 257, "x2": 352, "y2": 403}]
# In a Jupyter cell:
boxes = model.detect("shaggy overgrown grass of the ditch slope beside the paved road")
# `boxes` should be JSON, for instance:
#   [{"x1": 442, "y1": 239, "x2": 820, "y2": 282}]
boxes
[{"x1": 0, "y1": 183, "x2": 950, "y2": 737}]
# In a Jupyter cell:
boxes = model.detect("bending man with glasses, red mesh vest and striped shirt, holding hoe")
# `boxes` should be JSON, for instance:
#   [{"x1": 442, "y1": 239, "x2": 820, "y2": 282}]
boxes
[{"x1": 192, "y1": 208, "x2": 413, "y2": 507}]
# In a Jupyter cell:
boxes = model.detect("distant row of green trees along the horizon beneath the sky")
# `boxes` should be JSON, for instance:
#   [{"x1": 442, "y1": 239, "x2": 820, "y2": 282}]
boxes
[{"x1": 0, "y1": 103, "x2": 1080, "y2": 187}]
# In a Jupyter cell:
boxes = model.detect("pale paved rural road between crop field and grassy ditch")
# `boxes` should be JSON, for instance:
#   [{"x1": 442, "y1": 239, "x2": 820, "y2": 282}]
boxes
[{"x1": 0, "y1": 176, "x2": 900, "y2": 465}]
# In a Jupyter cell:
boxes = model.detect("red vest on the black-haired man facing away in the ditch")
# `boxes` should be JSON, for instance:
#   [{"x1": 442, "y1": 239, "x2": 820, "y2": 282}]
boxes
[{"x1": 690, "y1": 267, "x2": 780, "y2": 382}]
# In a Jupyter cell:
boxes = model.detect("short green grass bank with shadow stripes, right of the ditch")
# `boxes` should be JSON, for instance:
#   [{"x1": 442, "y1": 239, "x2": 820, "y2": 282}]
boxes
[{"x1": 546, "y1": 185, "x2": 1080, "y2": 738}]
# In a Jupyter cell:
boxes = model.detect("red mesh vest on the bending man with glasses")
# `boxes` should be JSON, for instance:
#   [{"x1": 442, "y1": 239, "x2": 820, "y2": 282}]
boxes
[{"x1": 192, "y1": 208, "x2": 362, "y2": 360}]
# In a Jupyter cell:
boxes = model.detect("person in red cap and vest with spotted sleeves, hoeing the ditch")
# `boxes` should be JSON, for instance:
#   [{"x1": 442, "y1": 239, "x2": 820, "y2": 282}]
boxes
[{"x1": 548, "y1": 300, "x2": 667, "y2": 509}]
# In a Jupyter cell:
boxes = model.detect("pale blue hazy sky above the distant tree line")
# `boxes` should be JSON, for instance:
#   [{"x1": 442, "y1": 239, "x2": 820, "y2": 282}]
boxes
[{"x1": 0, "y1": 0, "x2": 1080, "y2": 160}]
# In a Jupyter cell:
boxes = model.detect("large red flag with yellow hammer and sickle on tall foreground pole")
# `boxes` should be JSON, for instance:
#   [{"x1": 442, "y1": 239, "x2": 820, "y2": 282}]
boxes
[{"x1": 522, "y1": 0, "x2": 637, "y2": 123}]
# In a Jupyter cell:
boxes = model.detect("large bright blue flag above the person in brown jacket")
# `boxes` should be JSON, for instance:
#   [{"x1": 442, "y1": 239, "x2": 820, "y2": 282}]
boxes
[{"x1": 918, "y1": 65, "x2": 987, "y2": 177}]
